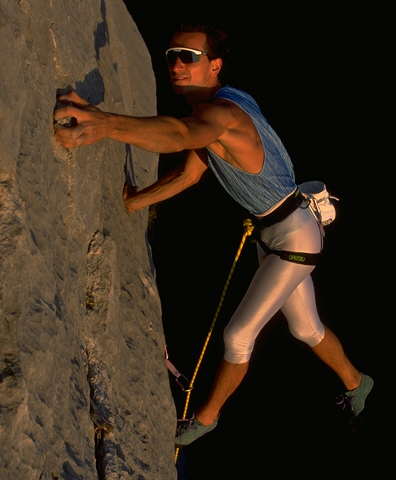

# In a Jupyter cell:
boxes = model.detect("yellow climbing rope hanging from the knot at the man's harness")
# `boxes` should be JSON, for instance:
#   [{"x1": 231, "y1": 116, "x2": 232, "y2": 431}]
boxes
[{"x1": 175, "y1": 218, "x2": 254, "y2": 463}]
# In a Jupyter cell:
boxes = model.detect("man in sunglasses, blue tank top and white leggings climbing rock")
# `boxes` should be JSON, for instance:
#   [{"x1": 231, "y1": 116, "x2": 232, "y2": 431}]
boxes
[{"x1": 55, "y1": 26, "x2": 373, "y2": 446}]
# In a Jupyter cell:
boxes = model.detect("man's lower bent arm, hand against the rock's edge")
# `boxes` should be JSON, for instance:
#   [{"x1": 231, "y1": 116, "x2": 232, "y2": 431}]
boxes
[{"x1": 124, "y1": 150, "x2": 208, "y2": 212}]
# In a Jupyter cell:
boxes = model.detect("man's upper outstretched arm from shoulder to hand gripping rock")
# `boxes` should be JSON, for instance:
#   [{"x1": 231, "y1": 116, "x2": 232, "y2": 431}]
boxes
[{"x1": 54, "y1": 92, "x2": 232, "y2": 153}]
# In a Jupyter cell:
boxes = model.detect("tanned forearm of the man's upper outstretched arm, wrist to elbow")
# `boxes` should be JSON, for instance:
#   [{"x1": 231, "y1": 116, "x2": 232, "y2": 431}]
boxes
[{"x1": 106, "y1": 113, "x2": 190, "y2": 153}]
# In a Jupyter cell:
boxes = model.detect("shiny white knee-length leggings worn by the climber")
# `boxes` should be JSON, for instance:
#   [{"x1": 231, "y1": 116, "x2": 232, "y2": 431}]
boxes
[{"x1": 224, "y1": 207, "x2": 324, "y2": 363}]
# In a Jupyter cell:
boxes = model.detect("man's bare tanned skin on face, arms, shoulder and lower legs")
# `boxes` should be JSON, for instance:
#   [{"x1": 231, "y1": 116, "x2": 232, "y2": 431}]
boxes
[{"x1": 54, "y1": 32, "x2": 361, "y2": 424}]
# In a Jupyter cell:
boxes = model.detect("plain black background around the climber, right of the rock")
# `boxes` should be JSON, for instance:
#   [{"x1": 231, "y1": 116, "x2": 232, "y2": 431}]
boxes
[{"x1": 125, "y1": 1, "x2": 382, "y2": 480}]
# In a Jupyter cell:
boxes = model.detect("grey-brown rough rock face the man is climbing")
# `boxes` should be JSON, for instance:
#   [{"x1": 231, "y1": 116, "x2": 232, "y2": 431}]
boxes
[{"x1": 0, "y1": 0, "x2": 176, "y2": 480}]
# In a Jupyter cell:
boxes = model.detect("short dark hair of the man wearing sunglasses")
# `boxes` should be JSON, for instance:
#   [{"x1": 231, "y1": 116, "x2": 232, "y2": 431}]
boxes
[{"x1": 173, "y1": 23, "x2": 230, "y2": 80}]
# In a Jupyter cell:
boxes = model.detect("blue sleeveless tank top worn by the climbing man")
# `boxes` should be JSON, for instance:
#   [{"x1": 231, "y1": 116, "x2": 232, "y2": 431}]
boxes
[{"x1": 206, "y1": 86, "x2": 296, "y2": 214}]
